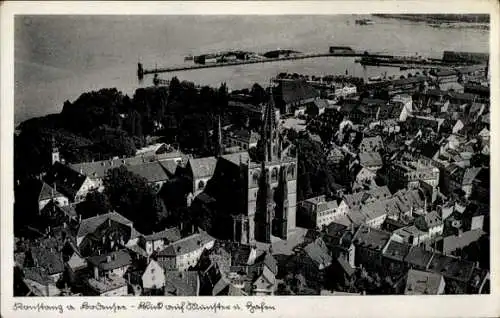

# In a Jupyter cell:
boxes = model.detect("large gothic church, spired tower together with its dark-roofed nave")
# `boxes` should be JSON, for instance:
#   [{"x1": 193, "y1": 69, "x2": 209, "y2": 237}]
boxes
[{"x1": 205, "y1": 97, "x2": 297, "y2": 244}]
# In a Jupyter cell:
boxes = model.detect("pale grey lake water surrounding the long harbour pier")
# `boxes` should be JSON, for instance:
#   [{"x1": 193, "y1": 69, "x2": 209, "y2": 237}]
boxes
[{"x1": 14, "y1": 15, "x2": 489, "y2": 124}]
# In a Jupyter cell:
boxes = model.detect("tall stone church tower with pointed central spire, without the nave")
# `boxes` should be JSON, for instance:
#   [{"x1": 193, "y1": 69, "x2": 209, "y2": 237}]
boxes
[{"x1": 246, "y1": 86, "x2": 297, "y2": 243}]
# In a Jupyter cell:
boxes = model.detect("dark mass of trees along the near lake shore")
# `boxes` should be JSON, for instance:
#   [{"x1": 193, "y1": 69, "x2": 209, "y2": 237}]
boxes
[{"x1": 15, "y1": 77, "x2": 232, "y2": 177}]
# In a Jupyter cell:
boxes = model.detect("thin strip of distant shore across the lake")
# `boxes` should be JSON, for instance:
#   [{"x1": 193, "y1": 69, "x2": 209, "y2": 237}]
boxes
[{"x1": 373, "y1": 14, "x2": 490, "y2": 30}]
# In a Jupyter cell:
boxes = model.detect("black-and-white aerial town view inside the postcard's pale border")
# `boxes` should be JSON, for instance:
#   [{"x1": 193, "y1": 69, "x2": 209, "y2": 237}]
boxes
[{"x1": 2, "y1": 0, "x2": 496, "y2": 316}]
